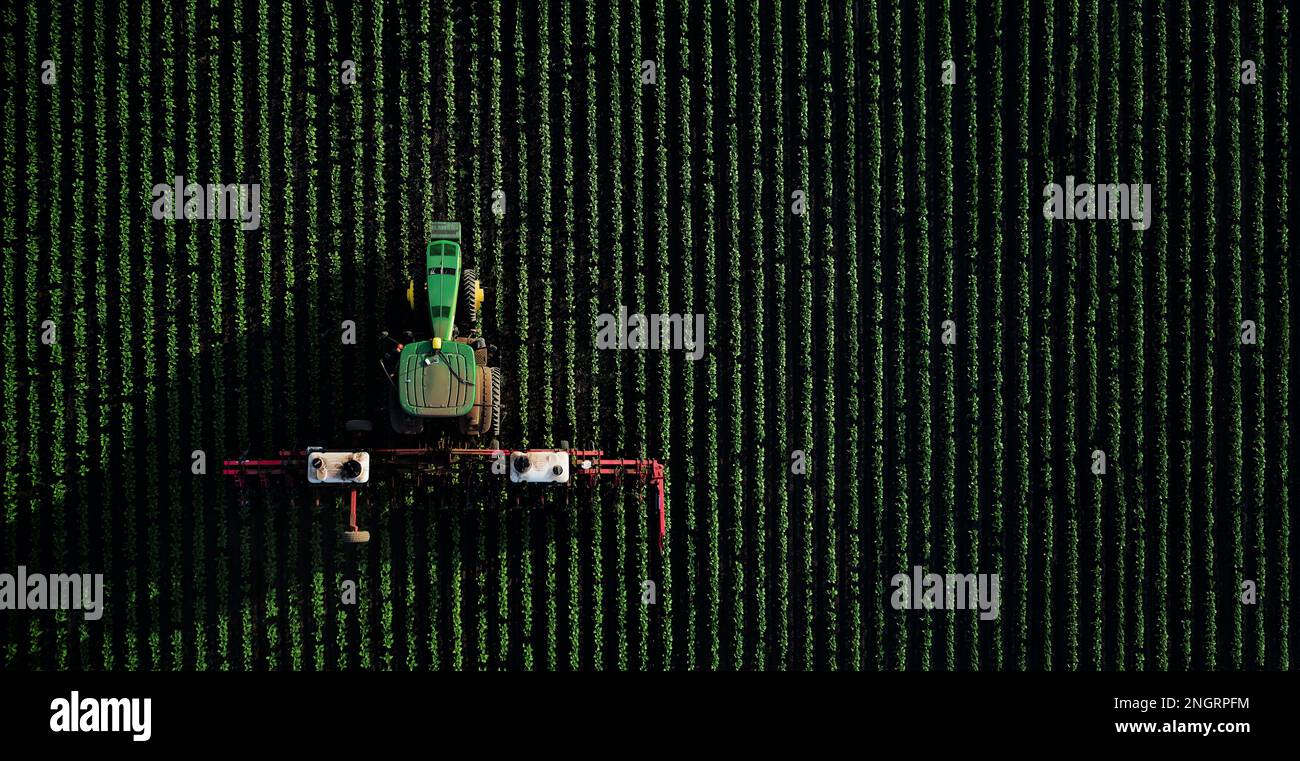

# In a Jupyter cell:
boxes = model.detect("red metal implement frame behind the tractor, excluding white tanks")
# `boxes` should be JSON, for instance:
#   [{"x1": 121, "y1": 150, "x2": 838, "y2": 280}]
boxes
[{"x1": 221, "y1": 447, "x2": 667, "y2": 552}]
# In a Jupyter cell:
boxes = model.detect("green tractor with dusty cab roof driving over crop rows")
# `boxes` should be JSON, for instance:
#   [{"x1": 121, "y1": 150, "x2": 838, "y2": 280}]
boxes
[{"x1": 385, "y1": 222, "x2": 502, "y2": 438}]
